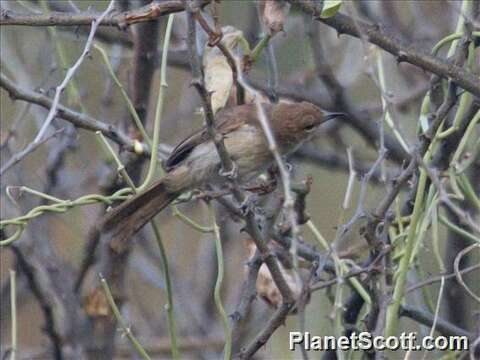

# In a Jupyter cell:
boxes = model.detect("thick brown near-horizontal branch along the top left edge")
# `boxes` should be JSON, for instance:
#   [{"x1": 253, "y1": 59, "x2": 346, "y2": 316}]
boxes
[{"x1": 0, "y1": 0, "x2": 210, "y2": 28}]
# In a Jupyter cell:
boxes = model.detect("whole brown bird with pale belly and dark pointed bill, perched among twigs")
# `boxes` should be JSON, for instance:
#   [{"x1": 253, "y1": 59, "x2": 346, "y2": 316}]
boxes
[{"x1": 102, "y1": 102, "x2": 342, "y2": 245}]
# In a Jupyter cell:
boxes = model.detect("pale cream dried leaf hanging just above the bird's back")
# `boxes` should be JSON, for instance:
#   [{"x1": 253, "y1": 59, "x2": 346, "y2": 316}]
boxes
[{"x1": 203, "y1": 26, "x2": 243, "y2": 114}]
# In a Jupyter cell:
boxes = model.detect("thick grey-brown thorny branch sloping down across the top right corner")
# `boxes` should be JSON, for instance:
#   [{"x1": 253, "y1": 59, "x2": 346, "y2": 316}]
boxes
[{"x1": 288, "y1": 0, "x2": 480, "y2": 96}]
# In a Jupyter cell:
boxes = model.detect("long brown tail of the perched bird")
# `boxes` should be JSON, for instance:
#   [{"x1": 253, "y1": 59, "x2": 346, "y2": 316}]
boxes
[{"x1": 100, "y1": 179, "x2": 179, "y2": 245}]
